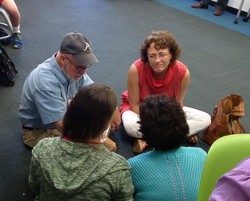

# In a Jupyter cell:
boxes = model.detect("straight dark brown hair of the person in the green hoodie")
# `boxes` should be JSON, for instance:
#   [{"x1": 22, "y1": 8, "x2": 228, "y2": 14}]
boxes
[{"x1": 63, "y1": 84, "x2": 117, "y2": 142}]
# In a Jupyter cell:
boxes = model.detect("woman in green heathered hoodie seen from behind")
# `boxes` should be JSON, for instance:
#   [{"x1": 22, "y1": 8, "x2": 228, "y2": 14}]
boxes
[{"x1": 29, "y1": 84, "x2": 134, "y2": 201}]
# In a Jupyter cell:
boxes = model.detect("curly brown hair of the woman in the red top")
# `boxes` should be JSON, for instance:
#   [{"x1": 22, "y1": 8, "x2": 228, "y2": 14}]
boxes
[{"x1": 140, "y1": 31, "x2": 181, "y2": 65}]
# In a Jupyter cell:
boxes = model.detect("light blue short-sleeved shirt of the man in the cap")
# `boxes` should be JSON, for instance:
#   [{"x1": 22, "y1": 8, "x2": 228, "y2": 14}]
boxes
[{"x1": 18, "y1": 55, "x2": 93, "y2": 129}]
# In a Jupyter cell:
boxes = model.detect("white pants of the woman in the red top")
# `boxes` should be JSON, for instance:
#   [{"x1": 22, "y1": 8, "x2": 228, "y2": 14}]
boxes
[{"x1": 122, "y1": 106, "x2": 211, "y2": 138}]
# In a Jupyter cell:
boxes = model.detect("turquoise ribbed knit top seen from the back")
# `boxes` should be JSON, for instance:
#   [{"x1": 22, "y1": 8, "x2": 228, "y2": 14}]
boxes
[{"x1": 128, "y1": 147, "x2": 206, "y2": 201}]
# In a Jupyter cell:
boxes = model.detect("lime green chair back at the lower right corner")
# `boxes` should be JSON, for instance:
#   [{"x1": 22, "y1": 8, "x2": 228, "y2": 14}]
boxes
[{"x1": 198, "y1": 134, "x2": 250, "y2": 201}]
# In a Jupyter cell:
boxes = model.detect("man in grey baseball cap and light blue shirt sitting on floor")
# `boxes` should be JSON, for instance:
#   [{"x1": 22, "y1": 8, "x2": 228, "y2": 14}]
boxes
[{"x1": 18, "y1": 32, "x2": 121, "y2": 151}]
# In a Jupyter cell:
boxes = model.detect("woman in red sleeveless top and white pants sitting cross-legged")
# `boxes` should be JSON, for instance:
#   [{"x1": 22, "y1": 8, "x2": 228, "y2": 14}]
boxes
[{"x1": 120, "y1": 31, "x2": 211, "y2": 153}]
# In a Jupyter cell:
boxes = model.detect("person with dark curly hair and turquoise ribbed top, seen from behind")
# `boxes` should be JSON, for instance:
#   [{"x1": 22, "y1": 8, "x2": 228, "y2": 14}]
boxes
[{"x1": 128, "y1": 95, "x2": 206, "y2": 201}]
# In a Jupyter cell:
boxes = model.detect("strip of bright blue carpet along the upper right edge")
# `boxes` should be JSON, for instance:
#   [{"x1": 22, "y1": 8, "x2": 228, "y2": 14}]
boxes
[{"x1": 156, "y1": 0, "x2": 250, "y2": 36}]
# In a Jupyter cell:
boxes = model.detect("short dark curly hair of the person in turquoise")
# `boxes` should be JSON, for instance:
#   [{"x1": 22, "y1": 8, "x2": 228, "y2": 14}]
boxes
[{"x1": 139, "y1": 95, "x2": 189, "y2": 151}]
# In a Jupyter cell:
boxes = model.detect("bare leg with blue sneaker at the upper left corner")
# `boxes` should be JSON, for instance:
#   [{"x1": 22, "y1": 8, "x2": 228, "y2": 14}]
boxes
[{"x1": 1, "y1": 0, "x2": 23, "y2": 49}]
